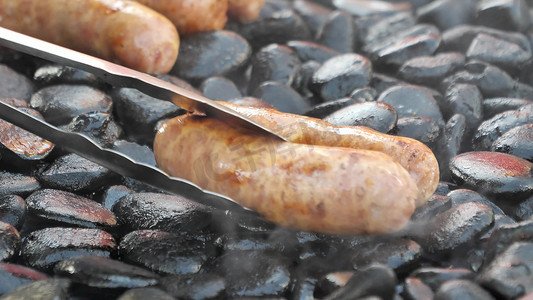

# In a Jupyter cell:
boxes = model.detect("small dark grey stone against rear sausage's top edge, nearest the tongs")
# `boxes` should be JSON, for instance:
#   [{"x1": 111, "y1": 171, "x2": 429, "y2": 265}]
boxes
[{"x1": 252, "y1": 81, "x2": 311, "y2": 114}]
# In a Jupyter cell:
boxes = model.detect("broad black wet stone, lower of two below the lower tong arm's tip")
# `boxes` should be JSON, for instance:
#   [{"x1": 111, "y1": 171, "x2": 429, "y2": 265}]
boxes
[{"x1": 119, "y1": 230, "x2": 214, "y2": 275}]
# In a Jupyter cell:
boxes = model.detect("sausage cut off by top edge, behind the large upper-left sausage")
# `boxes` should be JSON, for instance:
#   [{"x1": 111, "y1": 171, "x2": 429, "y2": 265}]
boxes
[{"x1": 136, "y1": 0, "x2": 228, "y2": 35}]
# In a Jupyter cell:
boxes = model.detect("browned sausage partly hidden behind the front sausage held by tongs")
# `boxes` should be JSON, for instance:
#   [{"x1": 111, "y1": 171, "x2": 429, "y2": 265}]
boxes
[{"x1": 219, "y1": 102, "x2": 439, "y2": 206}]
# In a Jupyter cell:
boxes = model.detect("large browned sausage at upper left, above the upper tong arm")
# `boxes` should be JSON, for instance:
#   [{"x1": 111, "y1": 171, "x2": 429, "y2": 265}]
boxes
[{"x1": 0, "y1": 0, "x2": 179, "y2": 73}]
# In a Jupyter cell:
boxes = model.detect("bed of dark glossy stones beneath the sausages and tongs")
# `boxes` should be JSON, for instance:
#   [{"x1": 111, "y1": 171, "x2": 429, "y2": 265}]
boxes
[{"x1": 0, "y1": 0, "x2": 533, "y2": 299}]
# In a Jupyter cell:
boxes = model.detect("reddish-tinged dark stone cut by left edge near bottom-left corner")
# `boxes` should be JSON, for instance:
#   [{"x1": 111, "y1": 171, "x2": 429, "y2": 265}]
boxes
[{"x1": 0, "y1": 263, "x2": 48, "y2": 295}]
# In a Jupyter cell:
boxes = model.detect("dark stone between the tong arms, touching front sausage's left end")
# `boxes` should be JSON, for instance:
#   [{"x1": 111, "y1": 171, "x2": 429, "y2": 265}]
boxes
[{"x1": 111, "y1": 88, "x2": 184, "y2": 143}]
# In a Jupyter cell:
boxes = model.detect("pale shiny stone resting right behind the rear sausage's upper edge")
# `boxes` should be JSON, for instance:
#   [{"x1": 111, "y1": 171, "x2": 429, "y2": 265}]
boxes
[{"x1": 324, "y1": 101, "x2": 398, "y2": 133}]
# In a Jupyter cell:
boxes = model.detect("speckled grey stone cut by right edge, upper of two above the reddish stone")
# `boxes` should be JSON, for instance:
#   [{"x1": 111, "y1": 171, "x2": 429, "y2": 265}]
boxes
[{"x1": 472, "y1": 104, "x2": 533, "y2": 150}]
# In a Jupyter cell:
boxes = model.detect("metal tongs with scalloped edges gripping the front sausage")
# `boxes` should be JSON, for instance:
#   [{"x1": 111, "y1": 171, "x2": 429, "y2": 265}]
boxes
[{"x1": 0, "y1": 27, "x2": 284, "y2": 212}]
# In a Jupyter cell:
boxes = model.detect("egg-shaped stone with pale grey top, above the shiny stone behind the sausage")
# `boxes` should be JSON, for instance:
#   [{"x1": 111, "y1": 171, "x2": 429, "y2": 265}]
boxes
[{"x1": 310, "y1": 53, "x2": 372, "y2": 101}]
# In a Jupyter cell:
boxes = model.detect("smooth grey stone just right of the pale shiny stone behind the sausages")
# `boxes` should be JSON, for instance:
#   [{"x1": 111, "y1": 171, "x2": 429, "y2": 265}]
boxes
[{"x1": 377, "y1": 85, "x2": 444, "y2": 124}]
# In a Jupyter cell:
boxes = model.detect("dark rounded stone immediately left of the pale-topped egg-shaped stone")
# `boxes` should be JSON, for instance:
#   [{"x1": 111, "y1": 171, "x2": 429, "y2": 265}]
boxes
[{"x1": 248, "y1": 44, "x2": 301, "y2": 93}]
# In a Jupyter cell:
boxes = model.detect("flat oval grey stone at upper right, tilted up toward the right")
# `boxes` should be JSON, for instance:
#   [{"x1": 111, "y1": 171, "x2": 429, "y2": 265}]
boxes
[{"x1": 398, "y1": 51, "x2": 465, "y2": 86}]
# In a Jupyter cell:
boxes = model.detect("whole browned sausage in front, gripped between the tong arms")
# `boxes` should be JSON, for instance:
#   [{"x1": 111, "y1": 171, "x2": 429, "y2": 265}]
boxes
[{"x1": 154, "y1": 116, "x2": 418, "y2": 234}]
